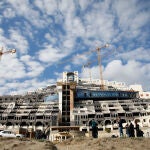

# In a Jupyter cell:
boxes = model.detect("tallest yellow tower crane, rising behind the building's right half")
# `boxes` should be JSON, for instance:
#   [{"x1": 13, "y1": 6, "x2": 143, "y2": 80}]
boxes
[{"x1": 96, "y1": 44, "x2": 109, "y2": 90}]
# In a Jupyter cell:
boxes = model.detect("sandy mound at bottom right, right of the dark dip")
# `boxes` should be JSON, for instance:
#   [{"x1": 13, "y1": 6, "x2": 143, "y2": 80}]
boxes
[{"x1": 57, "y1": 138, "x2": 150, "y2": 150}]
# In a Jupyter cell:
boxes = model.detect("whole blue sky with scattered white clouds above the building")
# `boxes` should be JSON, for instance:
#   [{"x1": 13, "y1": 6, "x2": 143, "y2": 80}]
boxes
[{"x1": 0, "y1": 0, "x2": 150, "y2": 95}]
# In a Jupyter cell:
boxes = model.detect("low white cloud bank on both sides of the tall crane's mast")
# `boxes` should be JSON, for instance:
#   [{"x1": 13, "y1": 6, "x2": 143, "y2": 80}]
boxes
[{"x1": 81, "y1": 60, "x2": 150, "y2": 90}]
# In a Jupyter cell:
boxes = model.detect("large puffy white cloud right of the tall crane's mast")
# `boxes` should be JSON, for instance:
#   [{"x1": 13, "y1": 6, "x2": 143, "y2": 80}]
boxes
[{"x1": 103, "y1": 60, "x2": 150, "y2": 89}]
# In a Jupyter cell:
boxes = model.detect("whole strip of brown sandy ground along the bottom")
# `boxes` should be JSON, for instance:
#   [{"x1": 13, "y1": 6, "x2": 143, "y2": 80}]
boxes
[{"x1": 0, "y1": 137, "x2": 150, "y2": 150}]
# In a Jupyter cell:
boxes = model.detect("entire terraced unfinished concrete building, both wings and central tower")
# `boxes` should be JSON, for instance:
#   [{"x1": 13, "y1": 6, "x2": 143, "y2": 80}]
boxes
[{"x1": 0, "y1": 71, "x2": 150, "y2": 135}]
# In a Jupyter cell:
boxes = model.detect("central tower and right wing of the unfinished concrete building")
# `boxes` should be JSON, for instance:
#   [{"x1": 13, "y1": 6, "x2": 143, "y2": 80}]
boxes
[{"x1": 57, "y1": 72, "x2": 150, "y2": 130}]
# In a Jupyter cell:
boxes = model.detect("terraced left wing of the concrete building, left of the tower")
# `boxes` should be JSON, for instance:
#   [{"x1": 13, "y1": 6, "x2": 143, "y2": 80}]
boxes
[{"x1": 0, "y1": 86, "x2": 59, "y2": 130}]
